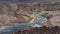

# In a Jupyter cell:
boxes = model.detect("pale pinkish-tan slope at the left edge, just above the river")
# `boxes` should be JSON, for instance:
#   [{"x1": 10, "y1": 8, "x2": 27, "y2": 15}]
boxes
[{"x1": 0, "y1": 14, "x2": 17, "y2": 26}]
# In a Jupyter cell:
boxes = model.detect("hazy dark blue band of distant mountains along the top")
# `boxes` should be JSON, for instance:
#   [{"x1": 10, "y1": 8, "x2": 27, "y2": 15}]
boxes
[{"x1": 0, "y1": 0, "x2": 60, "y2": 3}]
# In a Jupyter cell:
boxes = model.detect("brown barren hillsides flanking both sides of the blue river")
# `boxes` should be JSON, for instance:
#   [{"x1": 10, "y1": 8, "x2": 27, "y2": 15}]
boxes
[{"x1": 0, "y1": 2, "x2": 60, "y2": 26}]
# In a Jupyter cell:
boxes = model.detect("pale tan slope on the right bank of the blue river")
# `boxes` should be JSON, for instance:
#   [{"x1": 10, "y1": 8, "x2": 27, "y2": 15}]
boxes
[{"x1": 41, "y1": 11, "x2": 60, "y2": 27}]
